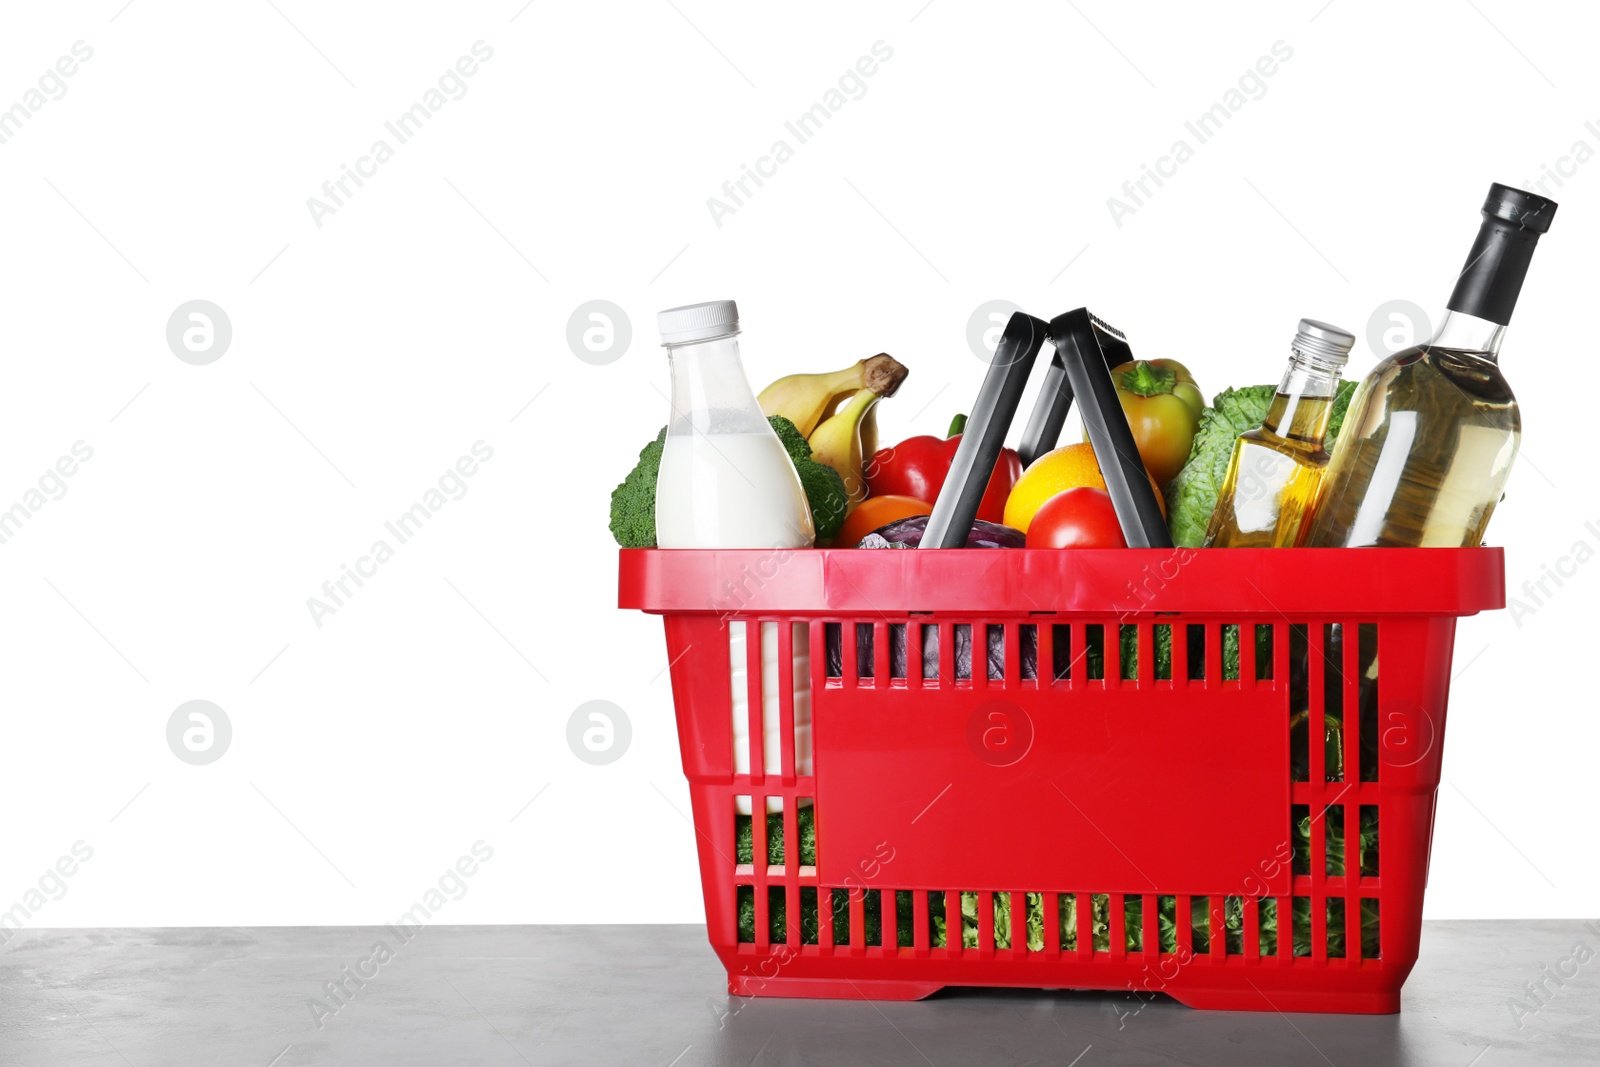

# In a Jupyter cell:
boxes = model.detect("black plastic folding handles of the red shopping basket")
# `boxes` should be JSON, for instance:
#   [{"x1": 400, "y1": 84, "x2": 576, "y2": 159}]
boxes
[{"x1": 922, "y1": 307, "x2": 1173, "y2": 549}]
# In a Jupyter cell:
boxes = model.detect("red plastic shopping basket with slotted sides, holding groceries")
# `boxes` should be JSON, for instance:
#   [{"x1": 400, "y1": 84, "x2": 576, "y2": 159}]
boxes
[{"x1": 619, "y1": 308, "x2": 1504, "y2": 1013}]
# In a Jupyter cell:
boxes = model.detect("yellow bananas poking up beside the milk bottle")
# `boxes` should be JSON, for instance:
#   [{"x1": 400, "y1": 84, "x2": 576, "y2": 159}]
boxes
[{"x1": 760, "y1": 352, "x2": 910, "y2": 509}]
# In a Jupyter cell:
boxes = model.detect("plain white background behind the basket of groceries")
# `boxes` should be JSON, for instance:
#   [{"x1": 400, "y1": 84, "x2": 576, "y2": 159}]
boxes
[{"x1": 0, "y1": 0, "x2": 1600, "y2": 926}]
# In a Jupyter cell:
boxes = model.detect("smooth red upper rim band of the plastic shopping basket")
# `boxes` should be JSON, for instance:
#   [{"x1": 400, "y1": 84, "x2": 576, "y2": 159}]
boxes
[{"x1": 618, "y1": 549, "x2": 1506, "y2": 619}]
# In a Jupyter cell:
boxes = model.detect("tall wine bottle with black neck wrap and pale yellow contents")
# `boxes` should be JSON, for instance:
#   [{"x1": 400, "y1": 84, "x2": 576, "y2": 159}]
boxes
[{"x1": 1306, "y1": 184, "x2": 1555, "y2": 547}]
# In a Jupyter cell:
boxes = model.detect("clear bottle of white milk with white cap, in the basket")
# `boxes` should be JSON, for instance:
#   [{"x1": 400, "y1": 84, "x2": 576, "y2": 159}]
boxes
[{"x1": 656, "y1": 301, "x2": 816, "y2": 814}]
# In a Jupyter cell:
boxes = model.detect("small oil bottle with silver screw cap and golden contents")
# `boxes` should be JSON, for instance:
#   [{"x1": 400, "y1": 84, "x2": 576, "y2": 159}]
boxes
[{"x1": 1205, "y1": 318, "x2": 1355, "y2": 549}]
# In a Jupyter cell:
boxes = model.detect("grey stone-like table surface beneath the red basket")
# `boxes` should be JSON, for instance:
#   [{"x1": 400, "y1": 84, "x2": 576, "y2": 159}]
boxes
[{"x1": 0, "y1": 920, "x2": 1600, "y2": 1067}]
